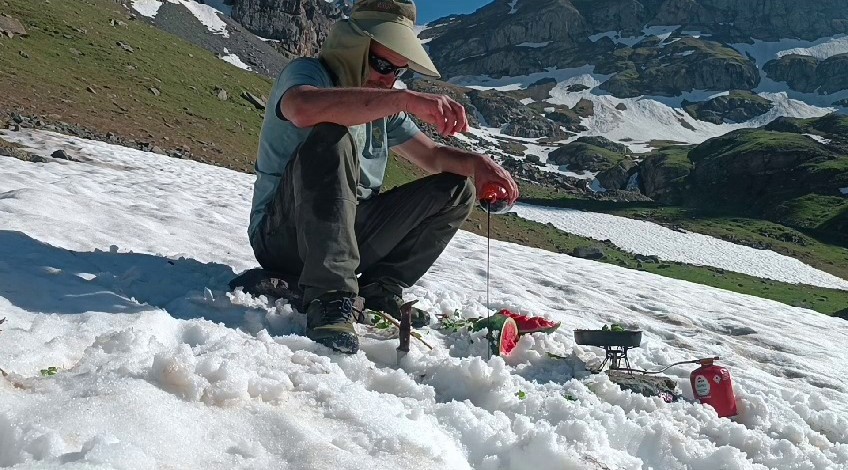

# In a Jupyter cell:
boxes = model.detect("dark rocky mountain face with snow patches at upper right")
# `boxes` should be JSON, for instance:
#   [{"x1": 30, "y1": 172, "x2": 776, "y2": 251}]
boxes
[{"x1": 422, "y1": 0, "x2": 848, "y2": 97}]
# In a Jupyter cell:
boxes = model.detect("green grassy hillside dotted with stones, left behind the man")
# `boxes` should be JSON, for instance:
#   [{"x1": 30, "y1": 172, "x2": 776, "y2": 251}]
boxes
[{"x1": 0, "y1": 0, "x2": 270, "y2": 170}]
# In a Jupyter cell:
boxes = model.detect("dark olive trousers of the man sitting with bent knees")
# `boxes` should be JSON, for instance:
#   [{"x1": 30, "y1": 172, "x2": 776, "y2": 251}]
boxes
[{"x1": 253, "y1": 124, "x2": 475, "y2": 305}]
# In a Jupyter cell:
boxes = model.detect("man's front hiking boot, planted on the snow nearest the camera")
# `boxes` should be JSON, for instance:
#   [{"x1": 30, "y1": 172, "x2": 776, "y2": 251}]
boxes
[{"x1": 306, "y1": 292, "x2": 359, "y2": 354}]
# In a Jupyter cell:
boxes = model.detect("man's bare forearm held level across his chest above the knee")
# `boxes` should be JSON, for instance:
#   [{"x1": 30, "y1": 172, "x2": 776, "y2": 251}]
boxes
[{"x1": 280, "y1": 86, "x2": 405, "y2": 127}]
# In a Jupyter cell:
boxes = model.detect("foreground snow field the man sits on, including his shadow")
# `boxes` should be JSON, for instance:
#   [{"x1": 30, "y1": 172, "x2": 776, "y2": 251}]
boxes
[{"x1": 0, "y1": 131, "x2": 848, "y2": 470}]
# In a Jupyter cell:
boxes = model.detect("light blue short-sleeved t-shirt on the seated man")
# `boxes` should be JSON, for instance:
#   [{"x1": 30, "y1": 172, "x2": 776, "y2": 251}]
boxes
[{"x1": 248, "y1": 58, "x2": 421, "y2": 239}]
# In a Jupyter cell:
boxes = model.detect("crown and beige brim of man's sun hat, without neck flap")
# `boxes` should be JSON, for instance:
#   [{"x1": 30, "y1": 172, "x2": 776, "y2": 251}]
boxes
[{"x1": 350, "y1": 0, "x2": 441, "y2": 78}]
